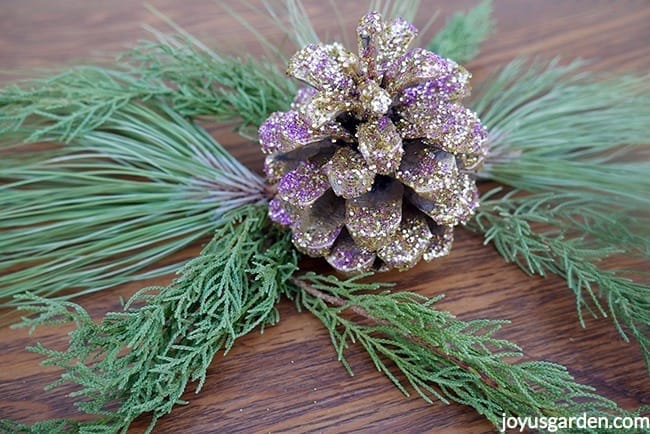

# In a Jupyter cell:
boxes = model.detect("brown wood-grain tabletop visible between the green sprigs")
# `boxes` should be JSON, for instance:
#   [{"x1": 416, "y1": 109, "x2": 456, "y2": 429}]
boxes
[{"x1": 0, "y1": 0, "x2": 650, "y2": 433}]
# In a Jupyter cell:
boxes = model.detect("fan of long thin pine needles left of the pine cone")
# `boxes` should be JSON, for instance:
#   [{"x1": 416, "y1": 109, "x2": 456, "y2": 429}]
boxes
[{"x1": 0, "y1": 104, "x2": 265, "y2": 306}]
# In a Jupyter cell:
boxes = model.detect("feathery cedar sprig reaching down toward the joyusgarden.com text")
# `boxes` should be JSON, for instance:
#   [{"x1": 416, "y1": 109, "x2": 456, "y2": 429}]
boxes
[{"x1": 290, "y1": 273, "x2": 641, "y2": 433}]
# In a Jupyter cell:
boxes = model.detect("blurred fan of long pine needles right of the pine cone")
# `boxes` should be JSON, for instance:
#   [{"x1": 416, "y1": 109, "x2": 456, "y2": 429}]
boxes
[{"x1": 473, "y1": 59, "x2": 650, "y2": 205}]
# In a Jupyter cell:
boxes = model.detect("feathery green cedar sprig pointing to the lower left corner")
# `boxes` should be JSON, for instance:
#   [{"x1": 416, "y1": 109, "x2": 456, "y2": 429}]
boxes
[{"x1": 8, "y1": 206, "x2": 297, "y2": 432}]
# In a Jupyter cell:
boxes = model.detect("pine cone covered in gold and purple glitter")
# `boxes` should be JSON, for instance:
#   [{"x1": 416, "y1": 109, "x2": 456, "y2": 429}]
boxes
[{"x1": 259, "y1": 12, "x2": 487, "y2": 272}]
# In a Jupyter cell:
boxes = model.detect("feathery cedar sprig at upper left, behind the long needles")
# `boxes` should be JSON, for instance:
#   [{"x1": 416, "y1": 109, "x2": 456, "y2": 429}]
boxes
[{"x1": 0, "y1": 39, "x2": 295, "y2": 147}]
